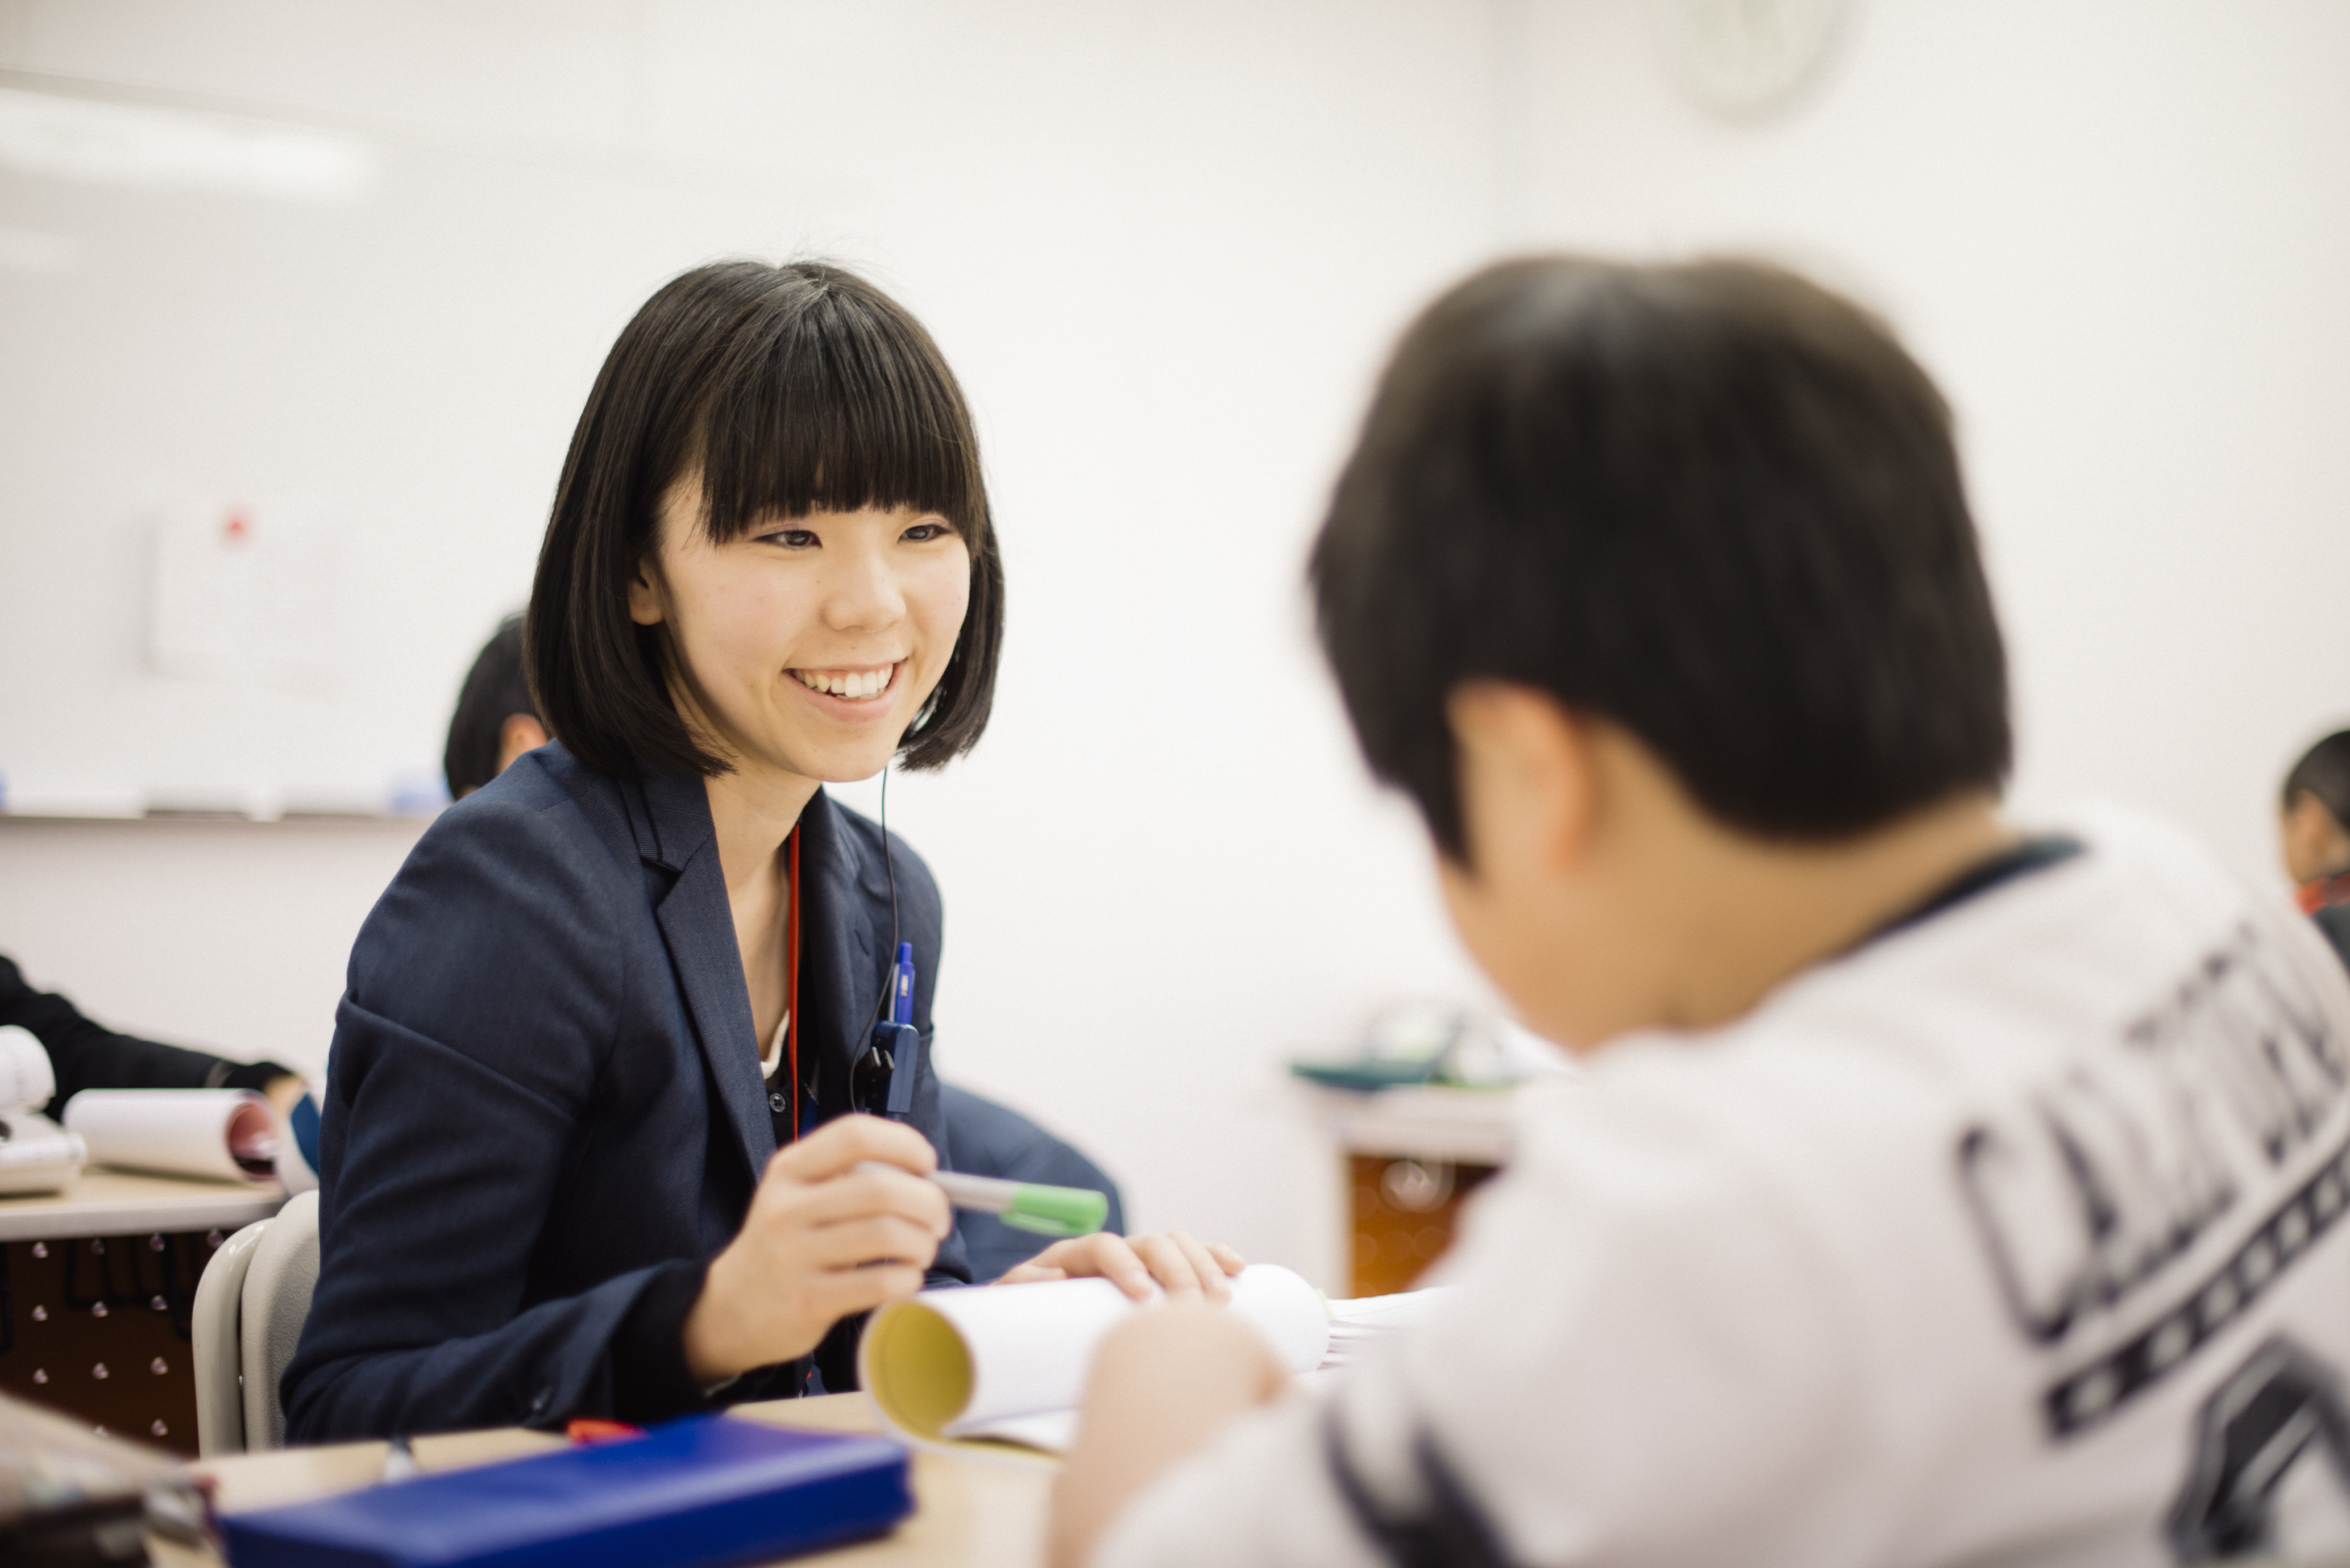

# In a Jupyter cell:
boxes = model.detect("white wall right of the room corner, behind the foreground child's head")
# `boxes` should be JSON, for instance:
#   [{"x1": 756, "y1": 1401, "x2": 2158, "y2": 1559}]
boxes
[{"x1": 1511, "y1": 0, "x2": 2350, "y2": 879}]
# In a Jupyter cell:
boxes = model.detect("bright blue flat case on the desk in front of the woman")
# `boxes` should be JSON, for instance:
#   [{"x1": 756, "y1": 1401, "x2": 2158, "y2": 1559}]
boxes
[{"x1": 221, "y1": 1415, "x2": 914, "y2": 1568}]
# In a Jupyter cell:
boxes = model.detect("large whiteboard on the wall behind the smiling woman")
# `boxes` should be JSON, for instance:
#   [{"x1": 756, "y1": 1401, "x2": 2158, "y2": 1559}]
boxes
[{"x1": 0, "y1": 87, "x2": 853, "y2": 816}]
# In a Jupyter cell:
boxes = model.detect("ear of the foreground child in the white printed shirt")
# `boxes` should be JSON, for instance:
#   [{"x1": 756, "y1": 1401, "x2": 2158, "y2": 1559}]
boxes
[{"x1": 1445, "y1": 679, "x2": 1600, "y2": 877}]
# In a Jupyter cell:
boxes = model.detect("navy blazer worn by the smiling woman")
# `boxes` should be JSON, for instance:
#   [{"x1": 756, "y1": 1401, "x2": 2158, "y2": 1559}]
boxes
[{"x1": 280, "y1": 745, "x2": 968, "y2": 1444}]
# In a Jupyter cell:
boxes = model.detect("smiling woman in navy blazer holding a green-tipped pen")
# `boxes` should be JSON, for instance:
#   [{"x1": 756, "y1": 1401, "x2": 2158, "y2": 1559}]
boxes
[{"x1": 284, "y1": 261, "x2": 1239, "y2": 1441}]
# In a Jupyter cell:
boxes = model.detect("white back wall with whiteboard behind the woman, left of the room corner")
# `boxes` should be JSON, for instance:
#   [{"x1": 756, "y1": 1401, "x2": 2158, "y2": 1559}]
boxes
[{"x1": 0, "y1": 0, "x2": 1497, "y2": 1270}]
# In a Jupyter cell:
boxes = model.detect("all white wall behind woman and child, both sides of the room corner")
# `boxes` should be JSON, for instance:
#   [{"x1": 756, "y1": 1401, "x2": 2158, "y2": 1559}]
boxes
[{"x1": 14, "y1": 0, "x2": 2350, "y2": 1272}]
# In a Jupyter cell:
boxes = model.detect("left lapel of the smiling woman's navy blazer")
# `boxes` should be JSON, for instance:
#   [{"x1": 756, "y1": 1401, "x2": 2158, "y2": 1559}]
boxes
[{"x1": 630, "y1": 773, "x2": 775, "y2": 1180}]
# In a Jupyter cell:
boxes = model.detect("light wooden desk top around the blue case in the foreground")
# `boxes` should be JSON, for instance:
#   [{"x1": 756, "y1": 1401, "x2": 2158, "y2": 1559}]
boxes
[{"x1": 183, "y1": 1394, "x2": 1055, "y2": 1568}]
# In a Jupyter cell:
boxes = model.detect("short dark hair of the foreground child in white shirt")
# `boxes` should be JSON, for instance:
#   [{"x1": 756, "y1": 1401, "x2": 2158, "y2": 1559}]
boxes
[{"x1": 1311, "y1": 256, "x2": 2009, "y2": 860}]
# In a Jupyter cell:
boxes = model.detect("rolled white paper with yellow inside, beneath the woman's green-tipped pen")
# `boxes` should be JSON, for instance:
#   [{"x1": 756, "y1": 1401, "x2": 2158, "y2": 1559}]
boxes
[{"x1": 858, "y1": 1262, "x2": 1330, "y2": 1448}]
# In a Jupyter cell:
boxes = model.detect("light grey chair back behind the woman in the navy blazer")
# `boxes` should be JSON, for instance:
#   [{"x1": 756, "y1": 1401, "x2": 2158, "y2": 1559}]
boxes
[{"x1": 188, "y1": 1192, "x2": 317, "y2": 1458}]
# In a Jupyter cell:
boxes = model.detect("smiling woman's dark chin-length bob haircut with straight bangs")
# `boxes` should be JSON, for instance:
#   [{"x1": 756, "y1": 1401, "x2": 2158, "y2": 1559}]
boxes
[{"x1": 526, "y1": 261, "x2": 1003, "y2": 778}]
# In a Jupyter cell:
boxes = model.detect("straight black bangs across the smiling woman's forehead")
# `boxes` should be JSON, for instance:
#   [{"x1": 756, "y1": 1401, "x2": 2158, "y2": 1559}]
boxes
[{"x1": 696, "y1": 278, "x2": 985, "y2": 543}]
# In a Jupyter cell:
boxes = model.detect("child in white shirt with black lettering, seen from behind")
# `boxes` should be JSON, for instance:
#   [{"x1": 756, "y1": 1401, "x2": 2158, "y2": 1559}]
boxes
[{"x1": 1053, "y1": 259, "x2": 2350, "y2": 1568}]
